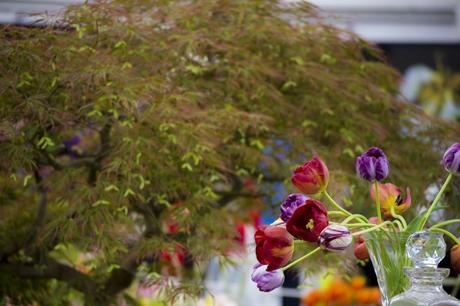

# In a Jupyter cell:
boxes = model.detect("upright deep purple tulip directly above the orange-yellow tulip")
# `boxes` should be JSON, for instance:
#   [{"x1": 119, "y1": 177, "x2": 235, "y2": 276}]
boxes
[{"x1": 355, "y1": 147, "x2": 390, "y2": 182}]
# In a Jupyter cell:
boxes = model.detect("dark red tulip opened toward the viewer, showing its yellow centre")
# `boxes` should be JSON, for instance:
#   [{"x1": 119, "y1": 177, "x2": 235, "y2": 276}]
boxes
[{"x1": 286, "y1": 199, "x2": 329, "y2": 242}]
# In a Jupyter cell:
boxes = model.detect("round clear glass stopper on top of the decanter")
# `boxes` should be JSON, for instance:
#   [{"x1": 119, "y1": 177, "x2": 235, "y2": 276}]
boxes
[{"x1": 406, "y1": 230, "x2": 446, "y2": 268}]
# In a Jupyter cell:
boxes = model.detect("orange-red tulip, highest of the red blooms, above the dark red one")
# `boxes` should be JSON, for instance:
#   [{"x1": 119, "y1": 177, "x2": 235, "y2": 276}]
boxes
[{"x1": 291, "y1": 156, "x2": 329, "y2": 194}]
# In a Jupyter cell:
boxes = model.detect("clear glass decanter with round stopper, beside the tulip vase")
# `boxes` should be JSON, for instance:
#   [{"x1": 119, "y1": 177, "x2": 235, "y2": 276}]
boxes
[{"x1": 390, "y1": 231, "x2": 460, "y2": 306}]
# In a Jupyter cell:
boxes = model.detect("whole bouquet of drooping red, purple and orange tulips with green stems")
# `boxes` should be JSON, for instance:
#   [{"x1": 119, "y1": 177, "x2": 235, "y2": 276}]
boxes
[{"x1": 252, "y1": 143, "x2": 460, "y2": 297}]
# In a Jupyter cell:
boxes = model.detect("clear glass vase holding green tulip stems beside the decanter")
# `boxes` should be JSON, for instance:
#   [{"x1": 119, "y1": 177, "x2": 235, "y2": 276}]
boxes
[{"x1": 364, "y1": 231, "x2": 410, "y2": 306}]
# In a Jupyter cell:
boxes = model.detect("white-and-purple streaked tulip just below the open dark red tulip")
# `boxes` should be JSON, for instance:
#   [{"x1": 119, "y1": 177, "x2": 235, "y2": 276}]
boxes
[{"x1": 318, "y1": 224, "x2": 353, "y2": 252}]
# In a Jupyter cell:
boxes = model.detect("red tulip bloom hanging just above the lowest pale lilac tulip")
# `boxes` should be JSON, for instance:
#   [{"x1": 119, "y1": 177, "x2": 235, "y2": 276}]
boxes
[{"x1": 254, "y1": 225, "x2": 294, "y2": 271}]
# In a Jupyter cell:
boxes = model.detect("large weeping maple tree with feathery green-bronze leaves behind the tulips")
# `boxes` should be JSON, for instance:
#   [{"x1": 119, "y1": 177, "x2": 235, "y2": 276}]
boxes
[{"x1": 0, "y1": 0, "x2": 459, "y2": 305}]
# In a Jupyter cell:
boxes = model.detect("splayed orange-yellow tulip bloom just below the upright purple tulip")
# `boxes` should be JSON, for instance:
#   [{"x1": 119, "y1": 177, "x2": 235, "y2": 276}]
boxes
[{"x1": 371, "y1": 183, "x2": 411, "y2": 218}]
